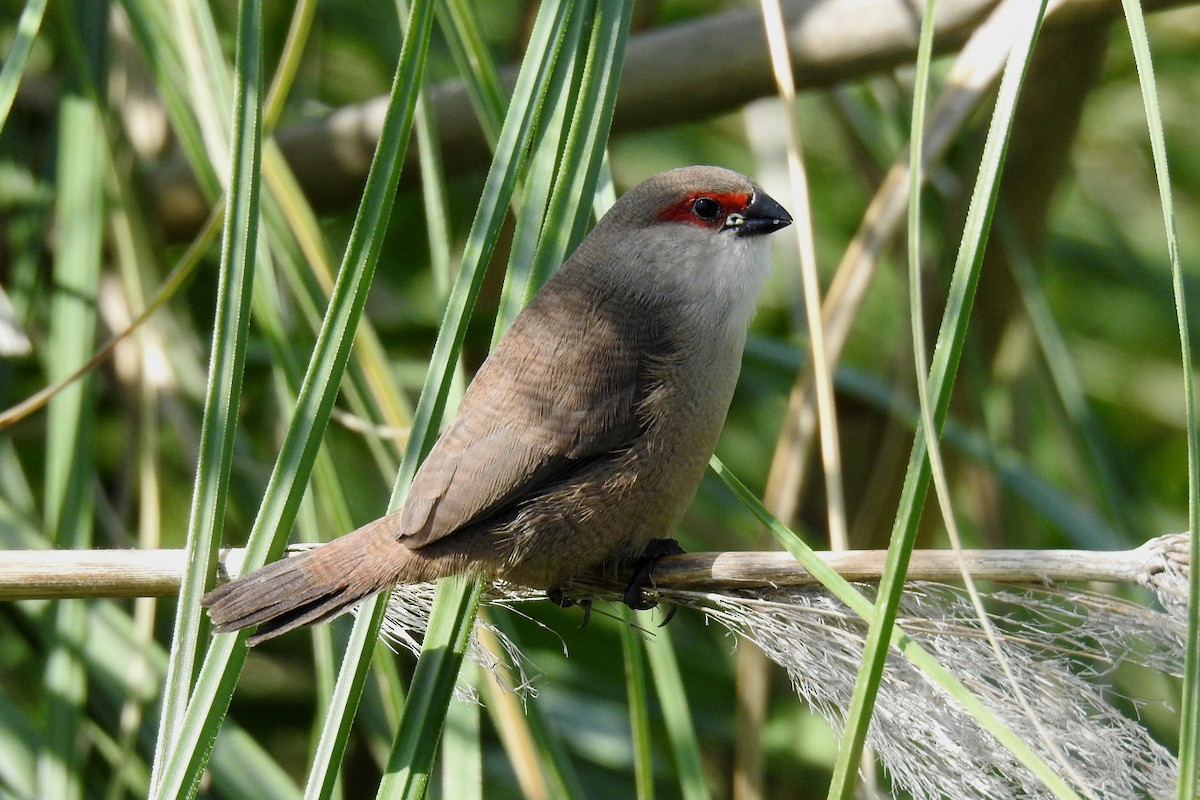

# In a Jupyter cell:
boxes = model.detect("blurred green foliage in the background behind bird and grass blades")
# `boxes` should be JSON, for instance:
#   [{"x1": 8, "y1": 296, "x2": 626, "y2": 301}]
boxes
[{"x1": 0, "y1": 0, "x2": 1200, "y2": 798}]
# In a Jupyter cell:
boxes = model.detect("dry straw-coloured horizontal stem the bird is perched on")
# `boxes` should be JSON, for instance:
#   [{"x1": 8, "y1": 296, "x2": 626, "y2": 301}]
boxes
[{"x1": 0, "y1": 534, "x2": 1188, "y2": 608}]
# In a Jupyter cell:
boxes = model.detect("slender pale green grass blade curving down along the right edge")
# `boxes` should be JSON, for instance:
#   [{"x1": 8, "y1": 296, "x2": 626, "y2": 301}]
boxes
[{"x1": 1121, "y1": 0, "x2": 1200, "y2": 800}]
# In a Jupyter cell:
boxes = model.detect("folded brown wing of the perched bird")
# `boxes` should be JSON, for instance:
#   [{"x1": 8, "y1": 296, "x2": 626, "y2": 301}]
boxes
[{"x1": 400, "y1": 267, "x2": 662, "y2": 547}]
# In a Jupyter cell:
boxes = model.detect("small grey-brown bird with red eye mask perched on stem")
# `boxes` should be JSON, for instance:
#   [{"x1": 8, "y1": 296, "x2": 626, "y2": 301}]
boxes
[{"x1": 202, "y1": 166, "x2": 792, "y2": 644}]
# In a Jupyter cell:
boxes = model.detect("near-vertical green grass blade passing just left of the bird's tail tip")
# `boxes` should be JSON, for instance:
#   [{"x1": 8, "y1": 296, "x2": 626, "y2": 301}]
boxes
[{"x1": 151, "y1": 0, "x2": 263, "y2": 794}]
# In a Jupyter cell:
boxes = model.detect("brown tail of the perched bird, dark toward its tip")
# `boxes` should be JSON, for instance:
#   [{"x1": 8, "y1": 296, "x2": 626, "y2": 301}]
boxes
[{"x1": 200, "y1": 517, "x2": 419, "y2": 645}]
